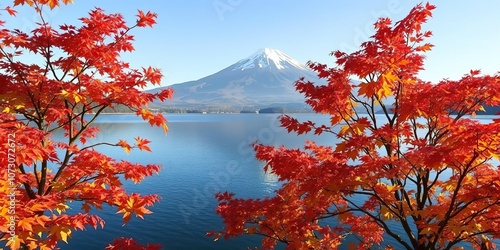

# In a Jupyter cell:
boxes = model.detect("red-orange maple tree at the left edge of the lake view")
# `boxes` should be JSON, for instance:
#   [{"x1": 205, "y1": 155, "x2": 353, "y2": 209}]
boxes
[{"x1": 0, "y1": 0, "x2": 172, "y2": 250}]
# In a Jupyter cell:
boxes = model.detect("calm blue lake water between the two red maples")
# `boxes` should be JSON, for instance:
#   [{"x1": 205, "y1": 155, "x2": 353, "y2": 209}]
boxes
[{"x1": 43, "y1": 114, "x2": 500, "y2": 250}]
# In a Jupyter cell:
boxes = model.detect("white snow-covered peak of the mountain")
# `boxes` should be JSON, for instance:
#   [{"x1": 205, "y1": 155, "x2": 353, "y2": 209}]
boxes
[{"x1": 232, "y1": 48, "x2": 309, "y2": 71}]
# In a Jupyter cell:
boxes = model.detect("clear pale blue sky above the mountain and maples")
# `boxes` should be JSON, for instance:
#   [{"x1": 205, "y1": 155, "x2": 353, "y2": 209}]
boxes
[{"x1": 2, "y1": 0, "x2": 500, "y2": 86}]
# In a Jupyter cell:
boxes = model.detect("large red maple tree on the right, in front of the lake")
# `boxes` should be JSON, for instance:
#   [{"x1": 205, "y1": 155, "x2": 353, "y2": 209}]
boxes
[{"x1": 213, "y1": 3, "x2": 500, "y2": 249}]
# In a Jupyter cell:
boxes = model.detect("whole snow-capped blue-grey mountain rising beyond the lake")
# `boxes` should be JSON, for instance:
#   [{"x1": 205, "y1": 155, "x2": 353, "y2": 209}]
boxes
[{"x1": 150, "y1": 48, "x2": 319, "y2": 110}]
